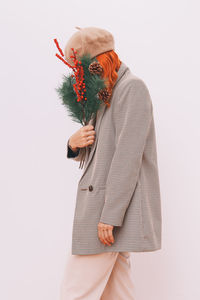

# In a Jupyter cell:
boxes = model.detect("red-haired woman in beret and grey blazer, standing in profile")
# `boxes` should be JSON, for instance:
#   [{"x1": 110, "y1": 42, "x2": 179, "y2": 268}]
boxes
[{"x1": 61, "y1": 27, "x2": 161, "y2": 300}]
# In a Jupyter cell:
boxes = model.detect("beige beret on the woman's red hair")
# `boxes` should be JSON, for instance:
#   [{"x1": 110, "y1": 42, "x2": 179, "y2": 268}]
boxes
[{"x1": 64, "y1": 26, "x2": 115, "y2": 65}]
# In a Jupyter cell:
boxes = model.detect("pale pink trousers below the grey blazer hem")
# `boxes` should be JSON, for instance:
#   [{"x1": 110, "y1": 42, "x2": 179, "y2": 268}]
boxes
[{"x1": 61, "y1": 252, "x2": 135, "y2": 300}]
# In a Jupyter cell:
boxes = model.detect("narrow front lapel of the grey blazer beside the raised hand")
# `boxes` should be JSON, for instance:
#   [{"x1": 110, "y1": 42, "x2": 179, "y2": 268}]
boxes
[{"x1": 79, "y1": 103, "x2": 106, "y2": 182}]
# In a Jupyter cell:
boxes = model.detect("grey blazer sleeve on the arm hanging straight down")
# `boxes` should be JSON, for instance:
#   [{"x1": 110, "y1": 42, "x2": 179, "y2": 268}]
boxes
[{"x1": 100, "y1": 79, "x2": 153, "y2": 226}]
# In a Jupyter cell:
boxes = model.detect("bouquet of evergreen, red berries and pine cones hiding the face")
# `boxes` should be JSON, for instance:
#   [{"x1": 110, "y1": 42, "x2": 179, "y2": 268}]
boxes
[{"x1": 54, "y1": 39, "x2": 111, "y2": 125}]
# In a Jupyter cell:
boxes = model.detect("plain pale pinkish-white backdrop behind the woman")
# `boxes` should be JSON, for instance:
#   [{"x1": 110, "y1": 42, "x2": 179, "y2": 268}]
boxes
[{"x1": 0, "y1": 0, "x2": 200, "y2": 300}]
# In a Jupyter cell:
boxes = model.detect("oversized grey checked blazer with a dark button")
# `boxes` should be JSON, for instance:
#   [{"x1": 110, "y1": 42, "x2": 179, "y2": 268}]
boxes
[{"x1": 67, "y1": 62, "x2": 162, "y2": 255}]
